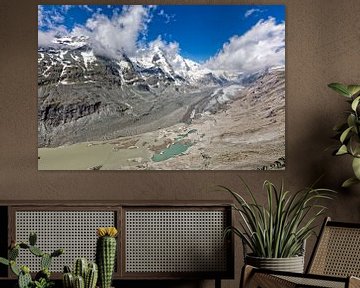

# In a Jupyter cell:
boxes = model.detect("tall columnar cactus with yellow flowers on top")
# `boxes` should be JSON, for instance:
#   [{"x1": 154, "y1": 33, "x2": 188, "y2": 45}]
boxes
[{"x1": 96, "y1": 227, "x2": 118, "y2": 288}]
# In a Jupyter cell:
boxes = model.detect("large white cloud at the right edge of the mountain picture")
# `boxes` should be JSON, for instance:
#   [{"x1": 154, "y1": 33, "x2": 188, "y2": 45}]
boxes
[{"x1": 204, "y1": 17, "x2": 285, "y2": 73}]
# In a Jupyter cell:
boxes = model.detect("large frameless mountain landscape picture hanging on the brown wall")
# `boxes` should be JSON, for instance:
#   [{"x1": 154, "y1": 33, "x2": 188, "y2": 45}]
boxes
[{"x1": 38, "y1": 5, "x2": 285, "y2": 170}]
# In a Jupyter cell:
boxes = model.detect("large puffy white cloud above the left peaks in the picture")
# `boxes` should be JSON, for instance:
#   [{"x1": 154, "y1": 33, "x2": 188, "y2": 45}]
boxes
[{"x1": 73, "y1": 5, "x2": 152, "y2": 57}]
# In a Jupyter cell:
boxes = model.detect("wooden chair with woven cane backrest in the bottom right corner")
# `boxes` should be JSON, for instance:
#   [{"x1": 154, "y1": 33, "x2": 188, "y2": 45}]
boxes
[{"x1": 240, "y1": 218, "x2": 360, "y2": 288}]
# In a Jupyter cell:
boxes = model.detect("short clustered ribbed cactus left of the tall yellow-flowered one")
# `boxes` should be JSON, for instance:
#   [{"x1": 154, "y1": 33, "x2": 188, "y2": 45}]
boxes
[{"x1": 63, "y1": 258, "x2": 98, "y2": 288}]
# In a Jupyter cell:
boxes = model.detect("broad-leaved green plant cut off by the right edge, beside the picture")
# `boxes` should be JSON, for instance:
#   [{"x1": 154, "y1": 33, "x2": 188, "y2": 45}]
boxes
[{"x1": 328, "y1": 83, "x2": 360, "y2": 187}]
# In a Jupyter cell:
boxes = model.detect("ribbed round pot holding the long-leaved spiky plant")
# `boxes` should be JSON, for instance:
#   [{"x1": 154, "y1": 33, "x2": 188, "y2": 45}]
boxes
[{"x1": 245, "y1": 255, "x2": 304, "y2": 273}]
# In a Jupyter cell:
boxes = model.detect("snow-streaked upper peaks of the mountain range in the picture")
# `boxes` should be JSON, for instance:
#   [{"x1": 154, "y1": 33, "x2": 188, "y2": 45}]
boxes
[{"x1": 38, "y1": 36, "x2": 233, "y2": 90}]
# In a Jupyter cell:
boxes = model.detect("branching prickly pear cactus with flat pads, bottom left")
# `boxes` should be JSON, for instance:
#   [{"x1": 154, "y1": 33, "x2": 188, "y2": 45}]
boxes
[{"x1": 0, "y1": 233, "x2": 64, "y2": 288}]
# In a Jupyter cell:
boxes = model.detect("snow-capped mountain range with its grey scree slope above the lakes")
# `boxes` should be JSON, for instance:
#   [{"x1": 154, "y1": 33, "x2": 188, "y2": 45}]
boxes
[{"x1": 38, "y1": 36, "x2": 280, "y2": 147}]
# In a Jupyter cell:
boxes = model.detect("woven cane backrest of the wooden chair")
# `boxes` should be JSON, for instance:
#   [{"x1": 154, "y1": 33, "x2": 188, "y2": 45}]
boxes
[{"x1": 307, "y1": 218, "x2": 360, "y2": 277}]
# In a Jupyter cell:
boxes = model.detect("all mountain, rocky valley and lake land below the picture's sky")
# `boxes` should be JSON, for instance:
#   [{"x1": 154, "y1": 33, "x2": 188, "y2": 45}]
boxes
[{"x1": 38, "y1": 37, "x2": 285, "y2": 170}]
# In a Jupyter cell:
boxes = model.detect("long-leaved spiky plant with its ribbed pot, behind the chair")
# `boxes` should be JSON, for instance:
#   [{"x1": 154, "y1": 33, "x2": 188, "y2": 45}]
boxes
[{"x1": 220, "y1": 180, "x2": 334, "y2": 273}]
